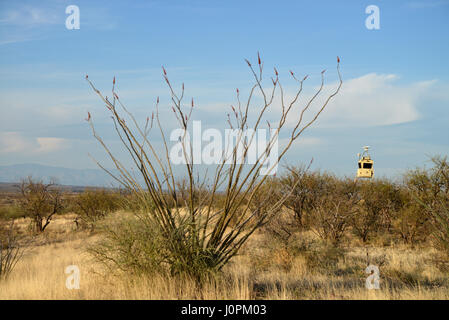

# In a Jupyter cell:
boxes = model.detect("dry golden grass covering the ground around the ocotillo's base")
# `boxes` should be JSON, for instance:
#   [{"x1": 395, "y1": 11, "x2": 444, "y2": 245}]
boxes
[{"x1": 0, "y1": 215, "x2": 449, "y2": 299}]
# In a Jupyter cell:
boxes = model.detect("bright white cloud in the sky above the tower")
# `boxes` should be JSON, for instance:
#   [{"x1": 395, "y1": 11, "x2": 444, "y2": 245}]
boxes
[{"x1": 276, "y1": 73, "x2": 436, "y2": 128}]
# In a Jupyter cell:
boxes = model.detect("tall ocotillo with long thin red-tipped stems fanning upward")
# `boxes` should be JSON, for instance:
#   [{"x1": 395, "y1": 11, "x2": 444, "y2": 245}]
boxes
[{"x1": 86, "y1": 55, "x2": 342, "y2": 276}]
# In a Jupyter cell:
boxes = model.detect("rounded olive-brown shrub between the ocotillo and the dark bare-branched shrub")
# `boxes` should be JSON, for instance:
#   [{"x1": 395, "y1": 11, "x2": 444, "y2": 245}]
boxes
[{"x1": 75, "y1": 189, "x2": 122, "y2": 231}]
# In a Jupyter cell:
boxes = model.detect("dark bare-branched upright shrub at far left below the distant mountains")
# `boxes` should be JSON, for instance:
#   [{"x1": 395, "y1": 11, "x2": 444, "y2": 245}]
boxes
[{"x1": 19, "y1": 177, "x2": 63, "y2": 232}]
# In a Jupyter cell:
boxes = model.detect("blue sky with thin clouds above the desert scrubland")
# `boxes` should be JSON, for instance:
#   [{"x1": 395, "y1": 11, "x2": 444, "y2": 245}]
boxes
[{"x1": 0, "y1": 0, "x2": 449, "y2": 182}]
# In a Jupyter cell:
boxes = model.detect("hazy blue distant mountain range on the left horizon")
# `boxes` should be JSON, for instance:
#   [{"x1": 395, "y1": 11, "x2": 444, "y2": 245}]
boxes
[{"x1": 0, "y1": 163, "x2": 117, "y2": 187}]
